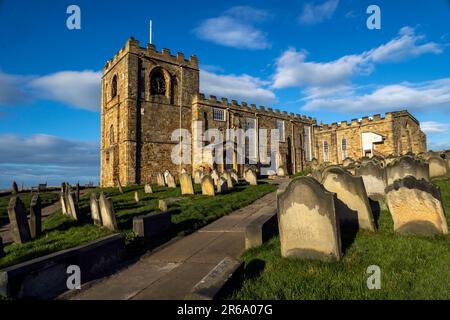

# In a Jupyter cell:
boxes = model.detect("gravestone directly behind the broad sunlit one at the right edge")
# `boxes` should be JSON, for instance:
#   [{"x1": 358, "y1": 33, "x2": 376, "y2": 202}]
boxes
[{"x1": 386, "y1": 156, "x2": 430, "y2": 185}]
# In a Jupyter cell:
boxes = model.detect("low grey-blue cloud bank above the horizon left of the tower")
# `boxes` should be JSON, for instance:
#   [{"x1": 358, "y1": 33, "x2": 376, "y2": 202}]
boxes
[{"x1": 0, "y1": 134, "x2": 100, "y2": 188}]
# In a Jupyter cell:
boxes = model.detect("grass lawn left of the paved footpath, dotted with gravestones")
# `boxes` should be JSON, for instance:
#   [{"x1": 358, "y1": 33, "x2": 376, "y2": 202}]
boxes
[{"x1": 0, "y1": 184, "x2": 276, "y2": 269}]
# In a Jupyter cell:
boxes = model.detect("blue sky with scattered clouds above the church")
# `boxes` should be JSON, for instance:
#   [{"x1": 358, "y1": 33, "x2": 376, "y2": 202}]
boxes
[{"x1": 0, "y1": 0, "x2": 450, "y2": 188}]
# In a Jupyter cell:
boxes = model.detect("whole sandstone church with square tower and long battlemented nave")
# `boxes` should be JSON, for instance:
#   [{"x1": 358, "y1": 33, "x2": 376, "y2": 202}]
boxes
[{"x1": 101, "y1": 38, "x2": 426, "y2": 187}]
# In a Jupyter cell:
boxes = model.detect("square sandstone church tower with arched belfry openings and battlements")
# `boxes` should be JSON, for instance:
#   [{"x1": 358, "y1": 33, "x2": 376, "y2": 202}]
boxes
[{"x1": 100, "y1": 38, "x2": 199, "y2": 187}]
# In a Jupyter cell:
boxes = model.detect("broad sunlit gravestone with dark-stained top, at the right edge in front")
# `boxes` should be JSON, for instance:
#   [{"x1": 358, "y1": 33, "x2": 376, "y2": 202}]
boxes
[{"x1": 386, "y1": 176, "x2": 448, "y2": 236}]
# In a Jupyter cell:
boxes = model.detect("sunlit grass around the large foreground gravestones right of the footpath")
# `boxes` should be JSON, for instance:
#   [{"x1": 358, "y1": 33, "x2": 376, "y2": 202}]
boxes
[{"x1": 228, "y1": 180, "x2": 450, "y2": 300}]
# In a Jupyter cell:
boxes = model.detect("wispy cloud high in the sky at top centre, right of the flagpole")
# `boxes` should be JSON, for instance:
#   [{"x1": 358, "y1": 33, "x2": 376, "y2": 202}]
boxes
[{"x1": 194, "y1": 6, "x2": 270, "y2": 50}]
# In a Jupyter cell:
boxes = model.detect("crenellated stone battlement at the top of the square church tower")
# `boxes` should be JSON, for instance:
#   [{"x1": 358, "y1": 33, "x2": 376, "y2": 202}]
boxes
[{"x1": 103, "y1": 37, "x2": 199, "y2": 73}]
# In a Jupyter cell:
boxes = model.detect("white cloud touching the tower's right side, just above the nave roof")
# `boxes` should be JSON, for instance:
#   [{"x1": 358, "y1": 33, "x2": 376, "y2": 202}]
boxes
[{"x1": 200, "y1": 70, "x2": 277, "y2": 104}]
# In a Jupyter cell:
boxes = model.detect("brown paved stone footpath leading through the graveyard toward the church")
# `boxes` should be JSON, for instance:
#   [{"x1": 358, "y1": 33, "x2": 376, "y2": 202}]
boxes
[{"x1": 59, "y1": 179, "x2": 289, "y2": 300}]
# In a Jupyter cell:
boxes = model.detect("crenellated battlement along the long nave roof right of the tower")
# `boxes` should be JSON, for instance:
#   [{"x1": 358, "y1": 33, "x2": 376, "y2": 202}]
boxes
[{"x1": 194, "y1": 93, "x2": 317, "y2": 125}]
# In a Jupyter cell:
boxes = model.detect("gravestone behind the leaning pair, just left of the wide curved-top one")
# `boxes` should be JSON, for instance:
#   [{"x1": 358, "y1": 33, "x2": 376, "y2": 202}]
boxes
[{"x1": 355, "y1": 161, "x2": 387, "y2": 197}]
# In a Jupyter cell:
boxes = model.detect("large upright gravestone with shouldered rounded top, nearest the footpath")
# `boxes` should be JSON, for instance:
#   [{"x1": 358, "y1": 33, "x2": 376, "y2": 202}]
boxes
[{"x1": 277, "y1": 177, "x2": 341, "y2": 261}]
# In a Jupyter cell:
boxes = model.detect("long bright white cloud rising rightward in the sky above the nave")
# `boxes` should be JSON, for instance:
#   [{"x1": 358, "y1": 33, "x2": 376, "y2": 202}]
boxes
[{"x1": 273, "y1": 27, "x2": 442, "y2": 88}]
